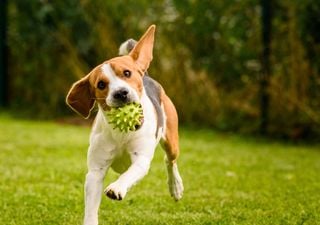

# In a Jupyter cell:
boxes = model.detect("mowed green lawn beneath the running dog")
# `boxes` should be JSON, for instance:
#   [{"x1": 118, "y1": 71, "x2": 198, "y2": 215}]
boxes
[{"x1": 0, "y1": 114, "x2": 320, "y2": 225}]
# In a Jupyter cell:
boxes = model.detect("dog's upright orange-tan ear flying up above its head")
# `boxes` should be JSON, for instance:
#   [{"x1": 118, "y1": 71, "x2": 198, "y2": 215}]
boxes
[{"x1": 129, "y1": 25, "x2": 156, "y2": 72}]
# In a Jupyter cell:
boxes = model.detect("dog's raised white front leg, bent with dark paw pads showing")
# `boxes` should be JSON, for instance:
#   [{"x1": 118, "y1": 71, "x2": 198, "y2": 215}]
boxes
[{"x1": 105, "y1": 146, "x2": 154, "y2": 200}]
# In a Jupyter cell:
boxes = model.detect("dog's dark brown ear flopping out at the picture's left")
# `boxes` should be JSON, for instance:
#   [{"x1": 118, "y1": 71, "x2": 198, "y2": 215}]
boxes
[{"x1": 66, "y1": 75, "x2": 95, "y2": 119}]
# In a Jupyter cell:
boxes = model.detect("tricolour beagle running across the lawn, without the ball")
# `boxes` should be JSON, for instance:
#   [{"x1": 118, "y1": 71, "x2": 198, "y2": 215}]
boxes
[{"x1": 66, "y1": 25, "x2": 183, "y2": 225}]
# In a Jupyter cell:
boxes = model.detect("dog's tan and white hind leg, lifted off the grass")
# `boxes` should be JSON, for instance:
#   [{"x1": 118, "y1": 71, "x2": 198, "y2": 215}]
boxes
[{"x1": 161, "y1": 93, "x2": 184, "y2": 201}]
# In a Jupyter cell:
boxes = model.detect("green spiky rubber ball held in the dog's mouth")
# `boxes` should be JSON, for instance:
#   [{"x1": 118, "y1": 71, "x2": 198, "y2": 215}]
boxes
[{"x1": 107, "y1": 102, "x2": 143, "y2": 133}]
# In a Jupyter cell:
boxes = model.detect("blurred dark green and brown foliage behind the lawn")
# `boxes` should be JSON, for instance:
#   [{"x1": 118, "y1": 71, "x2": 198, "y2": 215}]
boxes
[{"x1": 8, "y1": 0, "x2": 320, "y2": 138}]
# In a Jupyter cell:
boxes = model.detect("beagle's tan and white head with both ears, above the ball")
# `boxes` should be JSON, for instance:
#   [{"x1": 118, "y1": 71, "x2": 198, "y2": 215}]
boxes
[{"x1": 66, "y1": 25, "x2": 156, "y2": 118}]
